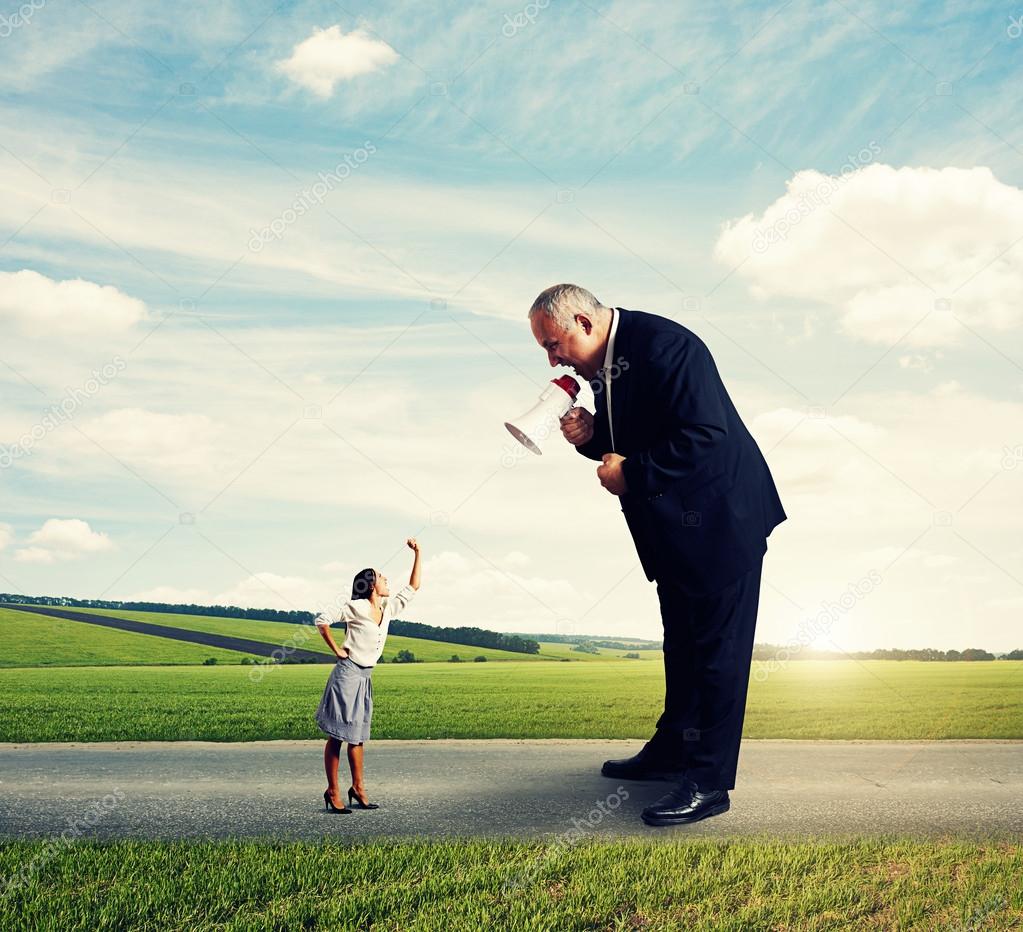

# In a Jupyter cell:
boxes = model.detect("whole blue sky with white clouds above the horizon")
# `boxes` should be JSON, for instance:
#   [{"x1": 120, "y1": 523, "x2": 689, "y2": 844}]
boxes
[{"x1": 0, "y1": 0, "x2": 1023, "y2": 651}]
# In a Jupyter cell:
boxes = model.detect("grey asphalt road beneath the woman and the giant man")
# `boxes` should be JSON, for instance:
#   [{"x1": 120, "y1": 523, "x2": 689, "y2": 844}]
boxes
[{"x1": 0, "y1": 740, "x2": 1023, "y2": 841}]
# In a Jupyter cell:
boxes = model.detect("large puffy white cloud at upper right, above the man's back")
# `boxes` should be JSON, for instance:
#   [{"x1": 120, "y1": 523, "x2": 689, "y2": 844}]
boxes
[{"x1": 714, "y1": 164, "x2": 1023, "y2": 345}]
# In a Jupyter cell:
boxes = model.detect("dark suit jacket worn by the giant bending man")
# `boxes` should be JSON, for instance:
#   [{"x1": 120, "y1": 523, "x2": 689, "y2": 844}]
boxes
[{"x1": 576, "y1": 308, "x2": 787, "y2": 595}]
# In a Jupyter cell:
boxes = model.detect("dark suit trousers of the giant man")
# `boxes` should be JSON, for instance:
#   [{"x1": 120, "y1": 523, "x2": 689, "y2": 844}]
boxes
[{"x1": 650, "y1": 557, "x2": 763, "y2": 790}]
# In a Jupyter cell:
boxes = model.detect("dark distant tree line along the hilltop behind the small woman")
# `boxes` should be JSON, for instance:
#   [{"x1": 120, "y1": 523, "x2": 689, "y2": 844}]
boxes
[{"x1": 0, "y1": 592, "x2": 540, "y2": 654}]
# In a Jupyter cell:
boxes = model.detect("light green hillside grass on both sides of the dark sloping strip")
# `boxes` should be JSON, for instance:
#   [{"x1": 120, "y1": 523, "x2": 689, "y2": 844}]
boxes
[{"x1": 0, "y1": 608, "x2": 661, "y2": 667}]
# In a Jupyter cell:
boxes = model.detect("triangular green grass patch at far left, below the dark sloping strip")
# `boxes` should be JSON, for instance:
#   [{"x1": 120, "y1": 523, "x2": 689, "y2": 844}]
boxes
[{"x1": 0, "y1": 609, "x2": 263, "y2": 667}]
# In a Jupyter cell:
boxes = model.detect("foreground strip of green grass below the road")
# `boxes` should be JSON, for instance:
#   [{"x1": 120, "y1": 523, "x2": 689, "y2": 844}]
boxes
[{"x1": 0, "y1": 839, "x2": 1023, "y2": 932}]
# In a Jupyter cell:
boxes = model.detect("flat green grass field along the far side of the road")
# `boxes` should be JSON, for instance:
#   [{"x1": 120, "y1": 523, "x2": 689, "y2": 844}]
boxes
[{"x1": 0, "y1": 660, "x2": 1023, "y2": 742}]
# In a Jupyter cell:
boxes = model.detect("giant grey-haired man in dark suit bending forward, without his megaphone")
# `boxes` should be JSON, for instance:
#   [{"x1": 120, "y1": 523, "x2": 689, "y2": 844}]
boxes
[{"x1": 529, "y1": 284, "x2": 786, "y2": 825}]
